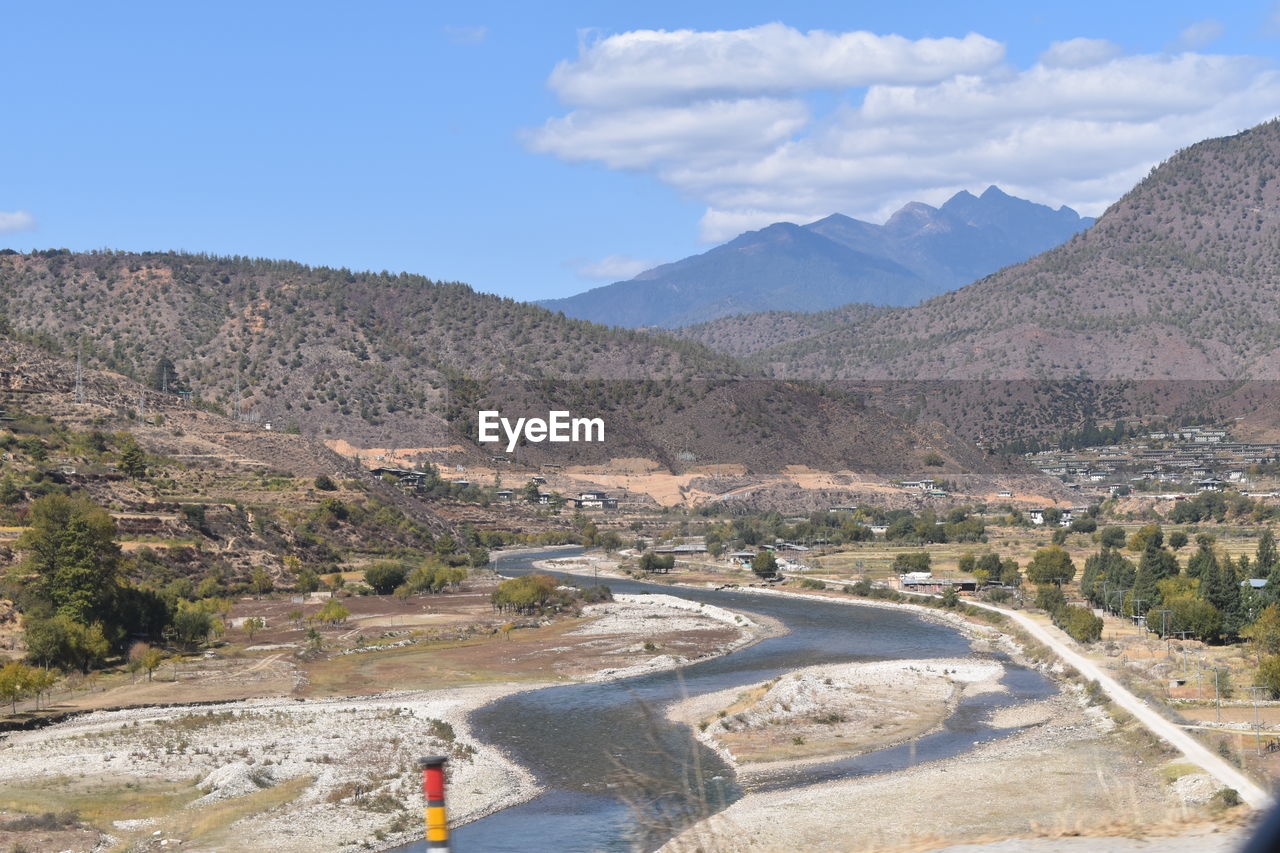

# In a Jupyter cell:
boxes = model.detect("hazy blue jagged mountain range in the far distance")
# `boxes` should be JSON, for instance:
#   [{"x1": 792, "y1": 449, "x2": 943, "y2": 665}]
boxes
[{"x1": 539, "y1": 187, "x2": 1093, "y2": 328}]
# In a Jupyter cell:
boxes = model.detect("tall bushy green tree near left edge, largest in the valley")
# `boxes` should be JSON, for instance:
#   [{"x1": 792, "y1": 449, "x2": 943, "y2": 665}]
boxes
[{"x1": 17, "y1": 494, "x2": 120, "y2": 628}]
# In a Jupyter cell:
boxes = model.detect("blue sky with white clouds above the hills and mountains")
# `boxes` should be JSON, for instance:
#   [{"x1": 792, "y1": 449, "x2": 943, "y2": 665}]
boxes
[{"x1": 0, "y1": 0, "x2": 1280, "y2": 300}]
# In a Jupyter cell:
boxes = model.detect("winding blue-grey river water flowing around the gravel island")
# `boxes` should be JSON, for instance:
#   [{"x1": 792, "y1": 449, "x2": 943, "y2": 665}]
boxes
[{"x1": 396, "y1": 548, "x2": 1055, "y2": 853}]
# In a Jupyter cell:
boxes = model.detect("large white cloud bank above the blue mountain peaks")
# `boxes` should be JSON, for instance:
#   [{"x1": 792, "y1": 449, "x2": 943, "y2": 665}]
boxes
[{"x1": 526, "y1": 24, "x2": 1280, "y2": 241}]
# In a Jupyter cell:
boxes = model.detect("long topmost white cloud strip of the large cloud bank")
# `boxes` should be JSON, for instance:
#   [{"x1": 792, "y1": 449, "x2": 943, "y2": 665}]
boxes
[{"x1": 549, "y1": 23, "x2": 1004, "y2": 108}]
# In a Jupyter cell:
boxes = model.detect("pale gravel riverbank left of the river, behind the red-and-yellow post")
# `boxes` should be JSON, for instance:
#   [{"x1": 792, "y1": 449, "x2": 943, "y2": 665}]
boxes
[{"x1": 0, "y1": 584, "x2": 772, "y2": 853}]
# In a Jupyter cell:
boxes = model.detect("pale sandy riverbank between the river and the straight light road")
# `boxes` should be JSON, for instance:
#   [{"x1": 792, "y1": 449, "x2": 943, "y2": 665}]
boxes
[{"x1": 662, "y1": 588, "x2": 1244, "y2": 853}]
